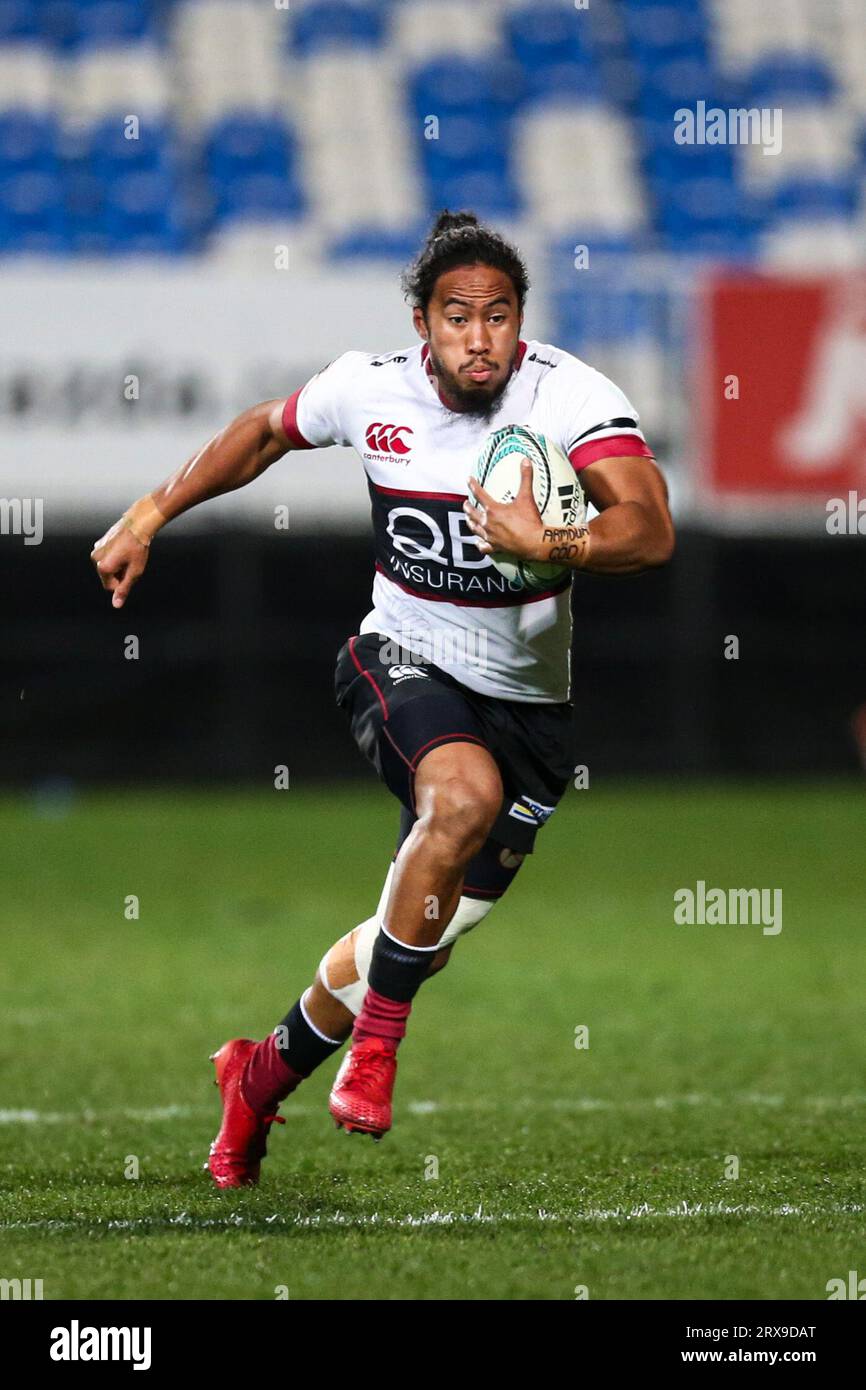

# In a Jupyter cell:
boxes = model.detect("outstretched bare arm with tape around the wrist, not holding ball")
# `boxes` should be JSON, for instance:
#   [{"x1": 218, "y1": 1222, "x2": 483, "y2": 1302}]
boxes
[{"x1": 90, "y1": 400, "x2": 291, "y2": 607}]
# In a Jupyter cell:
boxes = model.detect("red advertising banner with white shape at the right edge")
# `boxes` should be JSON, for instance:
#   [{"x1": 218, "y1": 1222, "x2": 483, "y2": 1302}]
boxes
[{"x1": 696, "y1": 274, "x2": 866, "y2": 503}]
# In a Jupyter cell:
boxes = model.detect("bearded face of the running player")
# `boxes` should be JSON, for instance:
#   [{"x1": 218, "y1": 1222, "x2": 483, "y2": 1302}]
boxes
[{"x1": 414, "y1": 265, "x2": 521, "y2": 420}]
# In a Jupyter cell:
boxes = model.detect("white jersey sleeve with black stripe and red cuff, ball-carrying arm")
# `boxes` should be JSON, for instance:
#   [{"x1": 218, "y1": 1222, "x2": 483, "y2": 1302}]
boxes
[{"x1": 556, "y1": 370, "x2": 653, "y2": 473}]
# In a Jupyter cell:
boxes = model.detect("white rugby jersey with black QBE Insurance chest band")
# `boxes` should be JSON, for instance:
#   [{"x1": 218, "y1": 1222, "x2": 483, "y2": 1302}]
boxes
[{"x1": 282, "y1": 341, "x2": 652, "y2": 703}]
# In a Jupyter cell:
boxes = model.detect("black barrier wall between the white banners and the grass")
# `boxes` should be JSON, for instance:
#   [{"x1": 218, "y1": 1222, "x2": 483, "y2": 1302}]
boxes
[{"x1": 0, "y1": 532, "x2": 866, "y2": 784}]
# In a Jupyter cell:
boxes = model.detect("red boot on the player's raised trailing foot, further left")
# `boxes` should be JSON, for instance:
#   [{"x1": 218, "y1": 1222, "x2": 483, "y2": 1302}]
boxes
[{"x1": 206, "y1": 1038, "x2": 285, "y2": 1187}]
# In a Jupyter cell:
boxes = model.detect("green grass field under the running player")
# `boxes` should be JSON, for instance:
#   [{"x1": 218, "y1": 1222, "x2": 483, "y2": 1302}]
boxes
[{"x1": 0, "y1": 784, "x2": 866, "y2": 1300}]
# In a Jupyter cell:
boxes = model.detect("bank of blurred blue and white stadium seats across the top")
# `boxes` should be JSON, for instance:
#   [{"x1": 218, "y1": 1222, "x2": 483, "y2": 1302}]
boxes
[{"x1": 0, "y1": 0, "x2": 866, "y2": 268}]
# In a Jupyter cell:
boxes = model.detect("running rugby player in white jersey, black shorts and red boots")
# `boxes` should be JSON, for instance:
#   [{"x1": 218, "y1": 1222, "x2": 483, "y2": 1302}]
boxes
[{"x1": 92, "y1": 211, "x2": 674, "y2": 1187}]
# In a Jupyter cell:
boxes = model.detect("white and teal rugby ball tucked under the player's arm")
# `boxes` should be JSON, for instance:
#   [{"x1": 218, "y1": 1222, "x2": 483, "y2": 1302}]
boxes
[{"x1": 474, "y1": 425, "x2": 587, "y2": 589}]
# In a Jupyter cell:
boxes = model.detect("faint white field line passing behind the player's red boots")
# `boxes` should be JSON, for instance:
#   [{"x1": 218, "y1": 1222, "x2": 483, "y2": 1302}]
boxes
[{"x1": 0, "y1": 1093, "x2": 866, "y2": 1125}]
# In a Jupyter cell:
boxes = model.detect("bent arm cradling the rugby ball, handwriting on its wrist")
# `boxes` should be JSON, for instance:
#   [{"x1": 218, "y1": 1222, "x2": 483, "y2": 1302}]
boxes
[{"x1": 464, "y1": 457, "x2": 674, "y2": 574}]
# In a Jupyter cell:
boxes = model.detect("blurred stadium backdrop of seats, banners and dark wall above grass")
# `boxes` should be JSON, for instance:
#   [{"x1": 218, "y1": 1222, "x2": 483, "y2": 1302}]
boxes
[{"x1": 0, "y1": 0, "x2": 866, "y2": 783}]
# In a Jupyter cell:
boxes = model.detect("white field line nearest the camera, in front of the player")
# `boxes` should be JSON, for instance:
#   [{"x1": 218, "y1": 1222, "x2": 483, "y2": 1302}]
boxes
[{"x1": 0, "y1": 1201, "x2": 866, "y2": 1233}]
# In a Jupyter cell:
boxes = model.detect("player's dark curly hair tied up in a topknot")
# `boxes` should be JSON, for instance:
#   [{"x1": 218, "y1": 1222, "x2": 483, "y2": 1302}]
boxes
[{"x1": 400, "y1": 209, "x2": 530, "y2": 313}]
